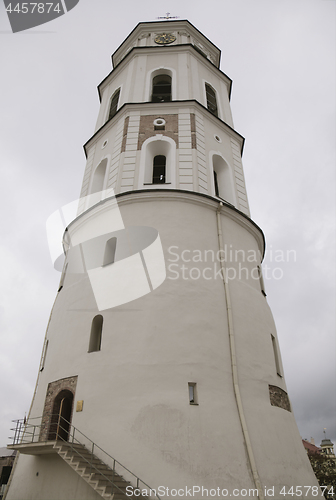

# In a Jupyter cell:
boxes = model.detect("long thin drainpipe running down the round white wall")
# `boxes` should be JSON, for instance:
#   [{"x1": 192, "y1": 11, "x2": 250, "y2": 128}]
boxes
[{"x1": 216, "y1": 202, "x2": 264, "y2": 500}]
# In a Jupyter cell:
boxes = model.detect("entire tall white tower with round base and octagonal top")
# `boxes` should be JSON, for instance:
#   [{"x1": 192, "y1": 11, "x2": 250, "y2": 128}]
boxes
[{"x1": 7, "y1": 20, "x2": 318, "y2": 500}]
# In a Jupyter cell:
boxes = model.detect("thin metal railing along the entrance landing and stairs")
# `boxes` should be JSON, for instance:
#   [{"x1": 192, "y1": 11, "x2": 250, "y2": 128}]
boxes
[{"x1": 10, "y1": 415, "x2": 161, "y2": 500}]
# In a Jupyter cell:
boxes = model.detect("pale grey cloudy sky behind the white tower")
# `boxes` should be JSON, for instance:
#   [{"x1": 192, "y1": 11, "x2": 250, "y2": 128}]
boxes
[{"x1": 0, "y1": 0, "x2": 336, "y2": 446}]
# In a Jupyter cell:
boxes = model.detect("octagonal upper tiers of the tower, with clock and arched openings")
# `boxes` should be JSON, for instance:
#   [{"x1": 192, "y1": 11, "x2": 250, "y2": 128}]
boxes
[{"x1": 81, "y1": 21, "x2": 250, "y2": 216}]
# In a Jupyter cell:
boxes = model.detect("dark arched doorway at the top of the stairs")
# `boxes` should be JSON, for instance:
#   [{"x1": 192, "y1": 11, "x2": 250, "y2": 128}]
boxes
[{"x1": 48, "y1": 389, "x2": 73, "y2": 441}]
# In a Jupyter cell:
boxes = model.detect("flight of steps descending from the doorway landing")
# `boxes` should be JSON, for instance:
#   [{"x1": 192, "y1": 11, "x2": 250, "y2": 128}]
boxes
[{"x1": 54, "y1": 441, "x2": 146, "y2": 500}]
